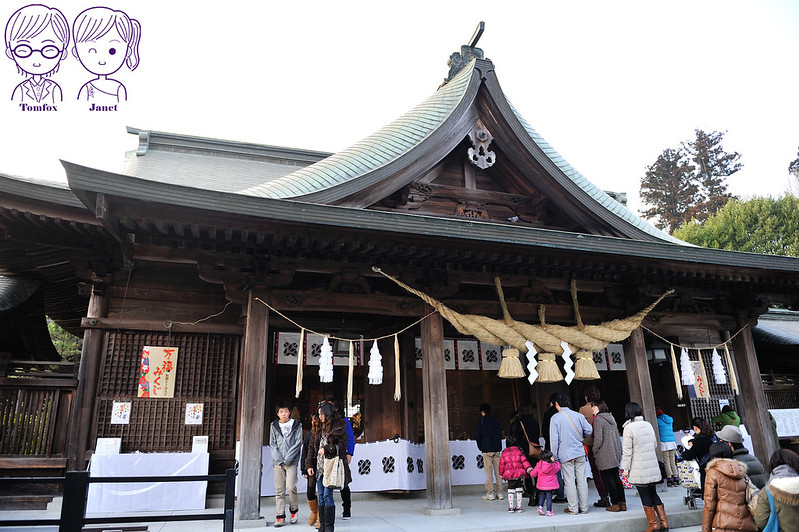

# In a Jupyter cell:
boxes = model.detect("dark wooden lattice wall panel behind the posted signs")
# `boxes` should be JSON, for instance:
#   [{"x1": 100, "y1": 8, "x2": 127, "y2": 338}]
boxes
[{"x1": 96, "y1": 331, "x2": 241, "y2": 452}]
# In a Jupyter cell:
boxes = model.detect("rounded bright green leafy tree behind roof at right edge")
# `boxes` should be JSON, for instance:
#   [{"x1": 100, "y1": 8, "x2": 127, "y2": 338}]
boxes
[{"x1": 674, "y1": 194, "x2": 799, "y2": 257}]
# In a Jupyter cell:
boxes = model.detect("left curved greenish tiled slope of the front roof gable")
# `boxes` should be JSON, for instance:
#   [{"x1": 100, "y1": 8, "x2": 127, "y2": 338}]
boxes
[{"x1": 241, "y1": 60, "x2": 480, "y2": 203}]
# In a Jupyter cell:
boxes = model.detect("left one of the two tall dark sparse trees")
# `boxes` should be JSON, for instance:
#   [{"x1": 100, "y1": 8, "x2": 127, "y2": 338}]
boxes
[{"x1": 641, "y1": 148, "x2": 697, "y2": 231}]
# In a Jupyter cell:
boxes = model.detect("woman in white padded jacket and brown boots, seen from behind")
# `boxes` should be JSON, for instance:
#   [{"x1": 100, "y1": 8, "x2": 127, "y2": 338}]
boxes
[{"x1": 621, "y1": 403, "x2": 669, "y2": 532}]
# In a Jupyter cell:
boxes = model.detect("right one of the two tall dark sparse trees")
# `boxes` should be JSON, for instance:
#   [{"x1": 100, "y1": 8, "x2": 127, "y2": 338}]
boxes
[{"x1": 683, "y1": 129, "x2": 743, "y2": 221}]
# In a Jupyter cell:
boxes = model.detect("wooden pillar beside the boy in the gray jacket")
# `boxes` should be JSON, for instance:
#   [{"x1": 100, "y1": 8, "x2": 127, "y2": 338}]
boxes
[{"x1": 236, "y1": 289, "x2": 269, "y2": 521}]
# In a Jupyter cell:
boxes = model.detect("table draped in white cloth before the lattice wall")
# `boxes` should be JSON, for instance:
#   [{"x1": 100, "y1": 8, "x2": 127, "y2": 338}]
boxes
[{"x1": 86, "y1": 453, "x2": 209, "y2": 513}]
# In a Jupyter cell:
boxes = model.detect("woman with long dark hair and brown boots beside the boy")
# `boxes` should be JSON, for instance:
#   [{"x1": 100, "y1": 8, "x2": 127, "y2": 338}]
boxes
[{"x1": 305, "y1": 402, "x2": 352, "y2": 532}]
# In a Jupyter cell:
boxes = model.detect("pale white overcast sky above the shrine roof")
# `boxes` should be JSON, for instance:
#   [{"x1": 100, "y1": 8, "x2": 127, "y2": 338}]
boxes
[{"x1": 0, "y1": 0, "x2": 799, "y2": 216}]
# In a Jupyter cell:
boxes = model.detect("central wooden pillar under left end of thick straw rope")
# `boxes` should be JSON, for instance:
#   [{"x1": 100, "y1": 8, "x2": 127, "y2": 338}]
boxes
[{"x1": 421, "y1": 307, "x2": 453, "y2": 513}]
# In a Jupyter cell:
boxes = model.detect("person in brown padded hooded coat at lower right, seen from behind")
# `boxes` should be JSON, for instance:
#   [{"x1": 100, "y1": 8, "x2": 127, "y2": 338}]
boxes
[{"x1": 702, "y1": 442, "x2": 757, "y2": 532}]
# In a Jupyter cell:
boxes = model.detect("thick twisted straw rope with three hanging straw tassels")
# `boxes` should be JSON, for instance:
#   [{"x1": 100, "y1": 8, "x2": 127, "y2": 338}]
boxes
[{"x1": 372, "y1": 266, "x2": 674, "y2": 382}]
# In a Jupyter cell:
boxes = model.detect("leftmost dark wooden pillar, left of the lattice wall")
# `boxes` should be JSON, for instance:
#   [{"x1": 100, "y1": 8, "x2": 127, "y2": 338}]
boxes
[{"x1": 67, "y1": 285, "x2": 108, "y2": 471}]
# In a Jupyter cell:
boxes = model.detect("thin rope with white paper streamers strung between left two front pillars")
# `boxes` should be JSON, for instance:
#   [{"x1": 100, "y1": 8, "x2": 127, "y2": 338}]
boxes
[{"x1": 255, "y1": 297, "x2": 437, "y2": 407}]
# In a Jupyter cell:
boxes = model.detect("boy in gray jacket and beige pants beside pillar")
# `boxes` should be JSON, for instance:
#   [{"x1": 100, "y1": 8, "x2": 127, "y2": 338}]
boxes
[{"x1": 269, "y1": 402, "x2": 302, "y2": 527}]
